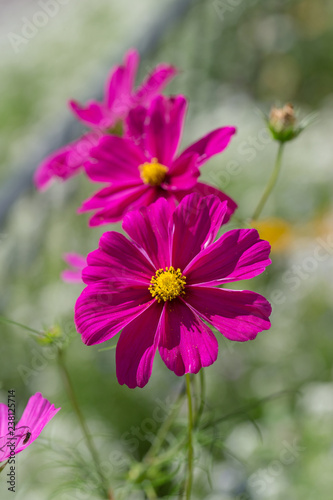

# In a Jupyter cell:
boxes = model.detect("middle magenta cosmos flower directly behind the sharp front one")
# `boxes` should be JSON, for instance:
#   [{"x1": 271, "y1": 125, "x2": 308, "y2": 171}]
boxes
[{"x1": 79, "y1": 95, "x2": 237, "y2": 226}]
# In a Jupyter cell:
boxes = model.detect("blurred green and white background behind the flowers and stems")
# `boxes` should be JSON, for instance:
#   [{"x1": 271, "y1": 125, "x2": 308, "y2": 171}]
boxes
[{"x1": 0, "y1": 0, "x2": 333, "y2": 500}]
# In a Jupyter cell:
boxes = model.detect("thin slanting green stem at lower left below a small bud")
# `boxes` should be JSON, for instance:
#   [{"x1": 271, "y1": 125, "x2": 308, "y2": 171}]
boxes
[{"x1": 58, "y1": 349, "x2": 113, "y2": 500}]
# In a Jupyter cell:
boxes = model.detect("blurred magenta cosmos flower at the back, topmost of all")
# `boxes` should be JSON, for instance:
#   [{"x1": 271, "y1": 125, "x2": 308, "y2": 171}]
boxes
[{"x1": 35, "y1": 49, "x2": 176, "y2": 189}]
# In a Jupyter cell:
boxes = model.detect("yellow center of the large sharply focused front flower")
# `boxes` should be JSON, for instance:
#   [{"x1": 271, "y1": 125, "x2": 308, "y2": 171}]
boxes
[{"x1": 149, "y1": 266, "x2": 186, "y2": 302}]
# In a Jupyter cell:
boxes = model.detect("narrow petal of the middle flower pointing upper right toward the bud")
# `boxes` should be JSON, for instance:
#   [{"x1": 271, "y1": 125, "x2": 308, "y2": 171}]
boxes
[{"x1": 182, "y1": 127, "x2": 236, "y2": 166}]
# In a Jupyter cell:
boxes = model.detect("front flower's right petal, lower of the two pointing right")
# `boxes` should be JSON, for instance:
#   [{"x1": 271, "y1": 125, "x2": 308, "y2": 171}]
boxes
[{"x1": 186, "y1": 286, "x2": 272, "y2": 342}]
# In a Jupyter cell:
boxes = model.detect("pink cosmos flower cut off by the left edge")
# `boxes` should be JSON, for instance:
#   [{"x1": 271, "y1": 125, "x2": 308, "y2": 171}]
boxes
[{"x1": 0, "y1": 392, "x2": 61, "y2": 462}]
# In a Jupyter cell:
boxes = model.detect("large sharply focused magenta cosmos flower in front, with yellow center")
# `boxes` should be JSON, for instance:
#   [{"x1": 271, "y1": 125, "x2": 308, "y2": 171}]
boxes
[{"x1": 75, "y1": 194, "x2": 271, "y2": 388}]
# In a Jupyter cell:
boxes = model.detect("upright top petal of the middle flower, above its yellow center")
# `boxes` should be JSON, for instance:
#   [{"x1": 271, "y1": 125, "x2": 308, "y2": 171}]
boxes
[{"x1": 146, "y1": 95, "x2": 187, "y2": 167}]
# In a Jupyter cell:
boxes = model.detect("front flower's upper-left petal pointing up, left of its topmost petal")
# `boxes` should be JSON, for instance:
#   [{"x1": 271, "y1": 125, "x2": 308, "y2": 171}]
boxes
[{"x1": 123, "y1": 198, "x2": 172, "y2": 269}]
